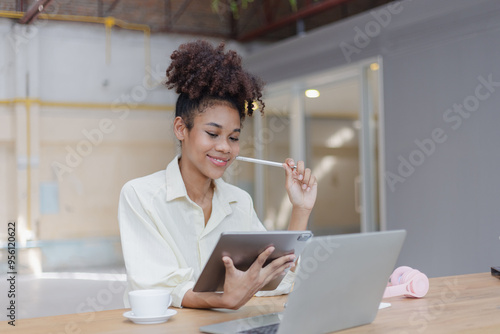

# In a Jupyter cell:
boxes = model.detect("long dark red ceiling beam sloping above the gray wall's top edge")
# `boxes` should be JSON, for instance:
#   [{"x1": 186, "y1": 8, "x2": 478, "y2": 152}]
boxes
[{"x1": 238, "y1": 0, "x2": 352, "y2": 42}]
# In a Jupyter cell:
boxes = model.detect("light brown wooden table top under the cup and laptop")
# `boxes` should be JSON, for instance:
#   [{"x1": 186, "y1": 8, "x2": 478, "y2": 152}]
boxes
[{"x1": 0, "y1": 273, "x2": 500, "y2": 334}]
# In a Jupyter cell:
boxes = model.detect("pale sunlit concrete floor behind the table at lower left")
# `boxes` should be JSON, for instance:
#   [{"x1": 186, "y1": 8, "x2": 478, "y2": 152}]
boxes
[{"x1": 9, "y1": 267, "x2": 126, "y2": 319}]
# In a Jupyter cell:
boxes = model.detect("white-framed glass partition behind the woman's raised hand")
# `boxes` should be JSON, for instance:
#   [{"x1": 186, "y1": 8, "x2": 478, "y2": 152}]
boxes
[{"x1": 253, "y1": 59, "x2": 383, "y2": 235}]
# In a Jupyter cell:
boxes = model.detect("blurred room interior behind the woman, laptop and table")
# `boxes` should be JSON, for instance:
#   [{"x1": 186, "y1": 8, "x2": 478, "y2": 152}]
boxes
[{"x1": 0, "y1": 0, "x2": 500, "y2": 318}]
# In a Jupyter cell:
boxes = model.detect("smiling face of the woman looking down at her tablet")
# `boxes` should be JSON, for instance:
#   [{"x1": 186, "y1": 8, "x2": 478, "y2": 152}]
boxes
[{"x1": 181, "y1": 104, "x2": 241, "y2": 179}]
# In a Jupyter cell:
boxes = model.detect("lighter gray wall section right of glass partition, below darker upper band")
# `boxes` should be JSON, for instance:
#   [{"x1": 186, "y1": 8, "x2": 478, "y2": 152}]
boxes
[{"x1": 384, "y1": 12, "x2": 500, "y2": 275}]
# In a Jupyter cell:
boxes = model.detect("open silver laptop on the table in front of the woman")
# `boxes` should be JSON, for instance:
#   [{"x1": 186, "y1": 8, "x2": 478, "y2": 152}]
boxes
[{"x1": 200, "y1": 230, "x2": 406, "y2": 334}]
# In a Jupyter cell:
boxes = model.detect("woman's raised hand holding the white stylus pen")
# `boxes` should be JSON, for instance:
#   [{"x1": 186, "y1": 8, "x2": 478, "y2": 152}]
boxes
[{"x1": 283, "y1": 158, "x2": 318, "y2": 211}]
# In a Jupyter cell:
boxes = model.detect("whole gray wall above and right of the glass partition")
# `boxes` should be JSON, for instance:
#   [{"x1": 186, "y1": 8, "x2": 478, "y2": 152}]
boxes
[{"x1": 245, "y1": 0, "x2": 500, "y2": 277}]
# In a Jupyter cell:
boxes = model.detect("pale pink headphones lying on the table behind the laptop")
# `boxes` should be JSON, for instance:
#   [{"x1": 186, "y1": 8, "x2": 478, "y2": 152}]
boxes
[{"x1": 382, "y1": 266, "x2": 429, "y2": 298}]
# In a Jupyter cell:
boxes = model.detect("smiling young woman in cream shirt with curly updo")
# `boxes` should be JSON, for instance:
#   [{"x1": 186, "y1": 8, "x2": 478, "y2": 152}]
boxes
[{"x1": 118, "y1": 41, "x2": 317, "y2": 309}]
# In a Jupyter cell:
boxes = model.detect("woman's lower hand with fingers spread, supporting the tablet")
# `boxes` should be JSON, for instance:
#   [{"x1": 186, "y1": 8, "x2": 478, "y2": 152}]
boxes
[{"x1": 221, "y1": 246, "x2": 295, "y2": 310}]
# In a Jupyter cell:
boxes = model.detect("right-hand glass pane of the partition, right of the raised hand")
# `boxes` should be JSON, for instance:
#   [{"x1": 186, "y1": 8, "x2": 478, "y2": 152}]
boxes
[{"x1": 305, "y1": 77, "x2": 361, "y2": 235}]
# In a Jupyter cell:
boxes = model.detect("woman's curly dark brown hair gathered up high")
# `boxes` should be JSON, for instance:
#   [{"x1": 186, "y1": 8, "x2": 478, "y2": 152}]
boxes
[{"x1": 166, "y1": 40, "x2": 264, "y2": 129}]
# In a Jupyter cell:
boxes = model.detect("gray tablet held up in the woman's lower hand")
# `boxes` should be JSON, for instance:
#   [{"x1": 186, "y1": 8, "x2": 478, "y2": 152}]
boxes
[{"x1": 193, "y1": 231, "x2": 313, "y2": 292}]
